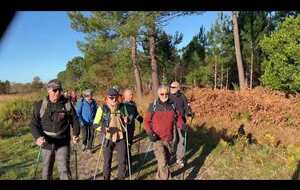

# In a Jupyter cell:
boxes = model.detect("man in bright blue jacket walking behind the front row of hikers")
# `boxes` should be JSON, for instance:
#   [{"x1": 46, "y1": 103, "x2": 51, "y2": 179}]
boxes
[{"x1": 76, "y1": 89, "x2": 97, "y2": 153}]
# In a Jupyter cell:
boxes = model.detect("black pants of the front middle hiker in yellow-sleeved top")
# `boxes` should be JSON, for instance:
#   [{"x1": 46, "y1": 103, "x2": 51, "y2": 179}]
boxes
[{"x1": 103, "y1": 139, "x2": 126, "y2": 180}]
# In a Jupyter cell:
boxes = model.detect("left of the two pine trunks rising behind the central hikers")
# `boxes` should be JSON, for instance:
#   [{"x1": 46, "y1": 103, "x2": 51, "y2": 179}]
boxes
[{"x1": 130, "y1": 36, "x2": 143, "y2": 103}]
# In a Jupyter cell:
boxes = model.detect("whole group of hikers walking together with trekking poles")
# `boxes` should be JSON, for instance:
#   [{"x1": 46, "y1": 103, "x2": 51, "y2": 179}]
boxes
[{"x1": 31, "y1": 79, "x2": 194, "y2": 180}]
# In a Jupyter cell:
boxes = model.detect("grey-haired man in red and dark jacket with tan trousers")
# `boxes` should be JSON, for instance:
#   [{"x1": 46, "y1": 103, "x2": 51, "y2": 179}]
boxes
[{"x1": 145, "y1": 86, "x2": 186, "y2": 180}]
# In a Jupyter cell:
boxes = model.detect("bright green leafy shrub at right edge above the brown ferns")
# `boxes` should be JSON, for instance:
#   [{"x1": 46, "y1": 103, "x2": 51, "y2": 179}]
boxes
[{"x1": 260, "y1": 16, "x2": 300, "y2": 93}]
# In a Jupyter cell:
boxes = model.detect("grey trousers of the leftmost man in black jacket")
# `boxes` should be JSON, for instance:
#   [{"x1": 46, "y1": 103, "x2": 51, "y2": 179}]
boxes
[{"x1": 42, "y1": 146, "x2": 71, "y2": 180}]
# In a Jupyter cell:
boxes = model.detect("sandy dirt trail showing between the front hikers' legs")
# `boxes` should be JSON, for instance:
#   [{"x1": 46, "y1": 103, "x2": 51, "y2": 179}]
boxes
[{"x1": 71, "y1": 133, "x2": 191, "y2": 180}]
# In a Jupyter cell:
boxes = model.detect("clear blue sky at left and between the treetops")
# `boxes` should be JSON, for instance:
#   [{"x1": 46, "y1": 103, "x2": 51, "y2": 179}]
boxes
[{"x1": 0, "y1": 11, "x2": 217, "y2": 83}]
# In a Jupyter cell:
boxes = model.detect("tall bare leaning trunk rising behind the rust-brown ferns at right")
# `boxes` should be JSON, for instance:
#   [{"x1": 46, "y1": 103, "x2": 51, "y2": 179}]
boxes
[{"x1": 232, "y1": 11, "x2": 247, "y2": 90}]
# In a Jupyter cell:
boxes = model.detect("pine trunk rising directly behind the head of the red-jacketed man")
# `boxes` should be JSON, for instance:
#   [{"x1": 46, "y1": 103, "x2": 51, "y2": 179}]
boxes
[{"x1": 149, "y1": 24, "x2": 159, "y2": 98}]
